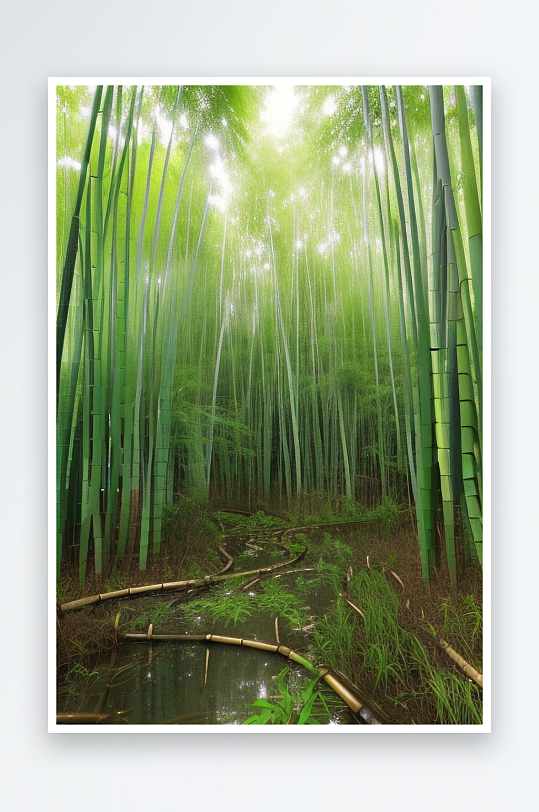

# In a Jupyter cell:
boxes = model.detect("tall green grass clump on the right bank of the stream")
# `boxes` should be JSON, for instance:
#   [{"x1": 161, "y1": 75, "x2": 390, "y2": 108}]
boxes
[{"x1": 312, "y1": 569, "x2": 482, "y2": 725}]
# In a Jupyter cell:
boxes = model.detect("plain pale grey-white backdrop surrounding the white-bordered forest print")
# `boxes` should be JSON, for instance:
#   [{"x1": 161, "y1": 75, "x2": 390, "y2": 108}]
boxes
[{"x1": 0, "y1": 0, "x2": 539, "y2": 812}]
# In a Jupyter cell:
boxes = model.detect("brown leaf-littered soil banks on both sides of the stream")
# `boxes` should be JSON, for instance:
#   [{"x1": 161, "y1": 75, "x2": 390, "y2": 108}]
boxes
[{"x1": 56, "y1": 504, "x2": 483, "y2": 725}]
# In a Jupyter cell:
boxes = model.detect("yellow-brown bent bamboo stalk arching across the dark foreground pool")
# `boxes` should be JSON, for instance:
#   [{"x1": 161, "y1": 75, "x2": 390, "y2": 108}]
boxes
[{"x1": 121, "y1": 632, "x2": 381, "y2": 724}]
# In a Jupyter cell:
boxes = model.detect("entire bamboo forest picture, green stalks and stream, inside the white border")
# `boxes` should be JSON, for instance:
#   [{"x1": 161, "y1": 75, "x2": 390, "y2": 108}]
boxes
[{"x1": 51, "y1": 80, "x2": 483, "y2": 731}]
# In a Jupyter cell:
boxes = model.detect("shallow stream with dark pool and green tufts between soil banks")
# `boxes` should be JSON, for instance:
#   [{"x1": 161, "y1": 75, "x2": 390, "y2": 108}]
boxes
[{"x1": 57, "y1": 532, "x2": 353, "y2": 726}]
